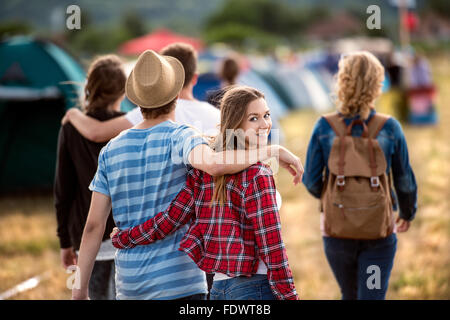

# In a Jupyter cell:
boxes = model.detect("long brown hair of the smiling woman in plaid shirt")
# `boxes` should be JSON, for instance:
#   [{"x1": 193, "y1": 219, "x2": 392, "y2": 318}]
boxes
[{"x1": 211, "y1": 86, "x2": 264, "y2": 205}]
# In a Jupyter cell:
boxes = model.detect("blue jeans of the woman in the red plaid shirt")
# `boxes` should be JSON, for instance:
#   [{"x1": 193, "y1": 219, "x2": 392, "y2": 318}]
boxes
[{"x1": 210, "y1": 274, "x2": 276, "y2": 300}]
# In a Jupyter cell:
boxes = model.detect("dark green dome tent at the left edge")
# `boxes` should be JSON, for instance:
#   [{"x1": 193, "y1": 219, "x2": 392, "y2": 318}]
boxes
[{"x1": 0, "y1": 37, "x2": 85, "y2": 193}]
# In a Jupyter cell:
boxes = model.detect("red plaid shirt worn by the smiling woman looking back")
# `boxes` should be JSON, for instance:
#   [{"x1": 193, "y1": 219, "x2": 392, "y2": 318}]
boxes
[{"x1": 112, "y1": 163, "x2": 298, "y2": 299}]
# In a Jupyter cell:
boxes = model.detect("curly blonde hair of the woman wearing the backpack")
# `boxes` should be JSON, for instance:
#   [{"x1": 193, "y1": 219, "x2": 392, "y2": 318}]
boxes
[{"x1": 336, "y1": 51, "x2": 384, "y2": 119}]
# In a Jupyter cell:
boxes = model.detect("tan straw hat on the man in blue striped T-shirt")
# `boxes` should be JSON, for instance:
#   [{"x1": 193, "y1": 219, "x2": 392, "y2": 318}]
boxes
[{"x1": 125, "y1": 50, "x2": 184, "y2": 108}]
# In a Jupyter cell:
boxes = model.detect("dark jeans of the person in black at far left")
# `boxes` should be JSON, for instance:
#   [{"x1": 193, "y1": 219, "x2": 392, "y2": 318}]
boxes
[{"x1": 89, "y1": 260, "x2": 116, "y2": 300}]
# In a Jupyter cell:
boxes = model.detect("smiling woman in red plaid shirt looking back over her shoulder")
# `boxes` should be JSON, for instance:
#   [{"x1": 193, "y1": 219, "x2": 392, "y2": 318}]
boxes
[{"x1": 112, "y1": 86, "x2": 298, "y2": 300}]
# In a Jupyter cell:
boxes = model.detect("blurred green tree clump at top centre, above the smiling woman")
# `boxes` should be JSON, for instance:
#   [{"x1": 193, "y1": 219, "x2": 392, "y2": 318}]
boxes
[{"x1": 203, "y1": 0, "x2": 330, "y2": 50}]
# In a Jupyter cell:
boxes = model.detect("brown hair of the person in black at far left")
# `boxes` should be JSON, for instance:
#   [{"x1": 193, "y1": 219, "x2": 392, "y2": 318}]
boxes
[{"x1": 83, "y1": 54, "x2": 127, "y2": 113}]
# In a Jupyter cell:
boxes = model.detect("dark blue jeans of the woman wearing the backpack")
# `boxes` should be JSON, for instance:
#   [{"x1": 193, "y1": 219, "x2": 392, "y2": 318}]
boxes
[{"x1": 323, "y1": 233, "x2": 397, "y2": 300}]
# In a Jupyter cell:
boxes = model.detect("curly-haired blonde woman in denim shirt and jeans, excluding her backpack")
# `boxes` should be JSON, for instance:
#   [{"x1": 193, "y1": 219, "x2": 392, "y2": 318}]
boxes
[{"x1": 303, "y1": 51, "x2": 417, "y2": 300}]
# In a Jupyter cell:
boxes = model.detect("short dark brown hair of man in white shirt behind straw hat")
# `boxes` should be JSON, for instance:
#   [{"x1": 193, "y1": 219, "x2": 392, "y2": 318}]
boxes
[{"x1": 160, "y1": 42, "x2": 197, "y2": 88}]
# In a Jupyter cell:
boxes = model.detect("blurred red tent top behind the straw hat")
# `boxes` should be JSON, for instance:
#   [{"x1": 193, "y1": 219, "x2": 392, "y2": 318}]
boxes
[{"x1": 119, "y1": 29, "x2": 203, "y2": 55}]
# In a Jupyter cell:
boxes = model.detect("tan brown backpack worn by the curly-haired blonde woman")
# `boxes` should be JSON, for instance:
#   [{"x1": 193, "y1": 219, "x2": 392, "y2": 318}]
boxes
[{"x1": 321, "y1": 113, "x2": 394, "y2": 239}]
